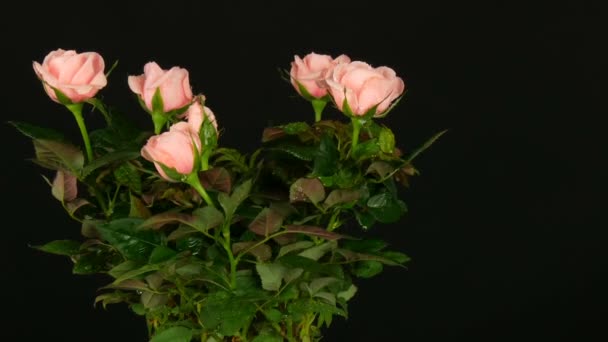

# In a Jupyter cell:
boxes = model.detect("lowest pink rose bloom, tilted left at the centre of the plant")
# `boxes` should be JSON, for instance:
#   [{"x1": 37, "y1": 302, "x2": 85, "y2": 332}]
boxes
[{"x1": 141, "y1": 122, "x2": 201, "y2": 181}]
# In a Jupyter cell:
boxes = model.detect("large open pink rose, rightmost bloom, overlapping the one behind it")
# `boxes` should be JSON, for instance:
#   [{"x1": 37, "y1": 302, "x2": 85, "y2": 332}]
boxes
[{"x1": 325, "y1": 61, "x2": 405, "y2": 116}]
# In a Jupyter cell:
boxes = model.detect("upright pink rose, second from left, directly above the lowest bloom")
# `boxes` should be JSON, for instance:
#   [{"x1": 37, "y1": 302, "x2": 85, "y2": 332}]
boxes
[{"x1": 128, "y1": 62, "x2": 192, "y2": 113}]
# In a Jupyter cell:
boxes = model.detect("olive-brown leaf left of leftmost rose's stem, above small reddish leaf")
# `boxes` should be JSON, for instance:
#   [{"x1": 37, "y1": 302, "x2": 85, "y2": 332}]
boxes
[{"x1": 34, "y1": 139, "x2": 84, "y2": 174}]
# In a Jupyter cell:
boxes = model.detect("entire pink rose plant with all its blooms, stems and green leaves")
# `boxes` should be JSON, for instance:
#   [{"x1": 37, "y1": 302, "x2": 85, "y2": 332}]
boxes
[{"x1": 12, "y1": 49, "x2": 443, "y2": 342}]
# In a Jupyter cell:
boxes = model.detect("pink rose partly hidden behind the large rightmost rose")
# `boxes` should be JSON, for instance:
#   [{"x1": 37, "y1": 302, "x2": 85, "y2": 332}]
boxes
[{"x1": 289, "y1": 52, "x2": 350, "y2": 99}]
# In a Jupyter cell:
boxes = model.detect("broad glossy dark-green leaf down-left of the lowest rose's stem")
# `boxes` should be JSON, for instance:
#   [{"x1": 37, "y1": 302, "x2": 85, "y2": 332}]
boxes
[{"x1": 97, "y1": 218, "x2": 160, "y2": 261}]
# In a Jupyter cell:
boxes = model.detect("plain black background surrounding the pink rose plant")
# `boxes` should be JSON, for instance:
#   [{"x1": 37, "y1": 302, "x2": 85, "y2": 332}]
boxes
[{"x1": 0, "y1": 0, "x2": 608, "y2": 342}]
